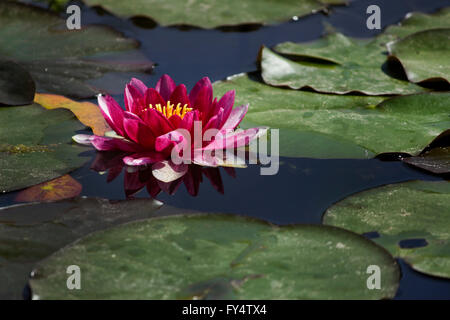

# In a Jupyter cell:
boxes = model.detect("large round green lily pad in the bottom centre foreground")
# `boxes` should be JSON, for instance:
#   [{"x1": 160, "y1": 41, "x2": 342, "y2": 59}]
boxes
[{"x1": 30, "y1": 214, "x2": 399, "y2": 299}]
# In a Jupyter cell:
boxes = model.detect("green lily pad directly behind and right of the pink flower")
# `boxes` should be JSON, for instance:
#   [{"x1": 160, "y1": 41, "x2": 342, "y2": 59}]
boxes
[{"x1": 214, "y1": 75, "x2": 450, "y2": 158}]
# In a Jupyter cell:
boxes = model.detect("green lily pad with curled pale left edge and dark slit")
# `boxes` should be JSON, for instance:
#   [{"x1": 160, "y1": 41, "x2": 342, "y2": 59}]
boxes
[{"x1": 260, "y1": 33, "x2": 425, "y2": 95}]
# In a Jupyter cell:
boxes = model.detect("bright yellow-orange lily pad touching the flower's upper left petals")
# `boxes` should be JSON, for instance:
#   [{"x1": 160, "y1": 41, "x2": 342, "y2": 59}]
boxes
[{"x1": 34, "y1": 93, "x2": 111, "y2": 136}]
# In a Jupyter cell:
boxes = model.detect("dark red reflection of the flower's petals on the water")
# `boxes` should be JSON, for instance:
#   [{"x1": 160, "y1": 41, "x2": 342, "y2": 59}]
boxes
[{"x1": 91, "y1": 152, "x2": 236, "y2": 198}]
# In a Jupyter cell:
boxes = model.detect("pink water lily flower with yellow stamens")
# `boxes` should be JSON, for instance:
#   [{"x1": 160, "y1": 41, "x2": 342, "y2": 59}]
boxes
[{"x1": 74, "y1": 75, "x2": 265, "y2": 170}]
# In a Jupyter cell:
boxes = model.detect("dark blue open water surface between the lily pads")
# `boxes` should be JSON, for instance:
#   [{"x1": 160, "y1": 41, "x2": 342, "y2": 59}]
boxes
[{"x1": 0, "y1": 0, "x2": 450, "y2": 299}]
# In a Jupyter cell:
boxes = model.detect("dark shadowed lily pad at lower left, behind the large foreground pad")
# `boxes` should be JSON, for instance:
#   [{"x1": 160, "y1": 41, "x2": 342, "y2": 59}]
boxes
[{"x1": 0, "y1": 198, "x2": 160, "y2": 299}]
